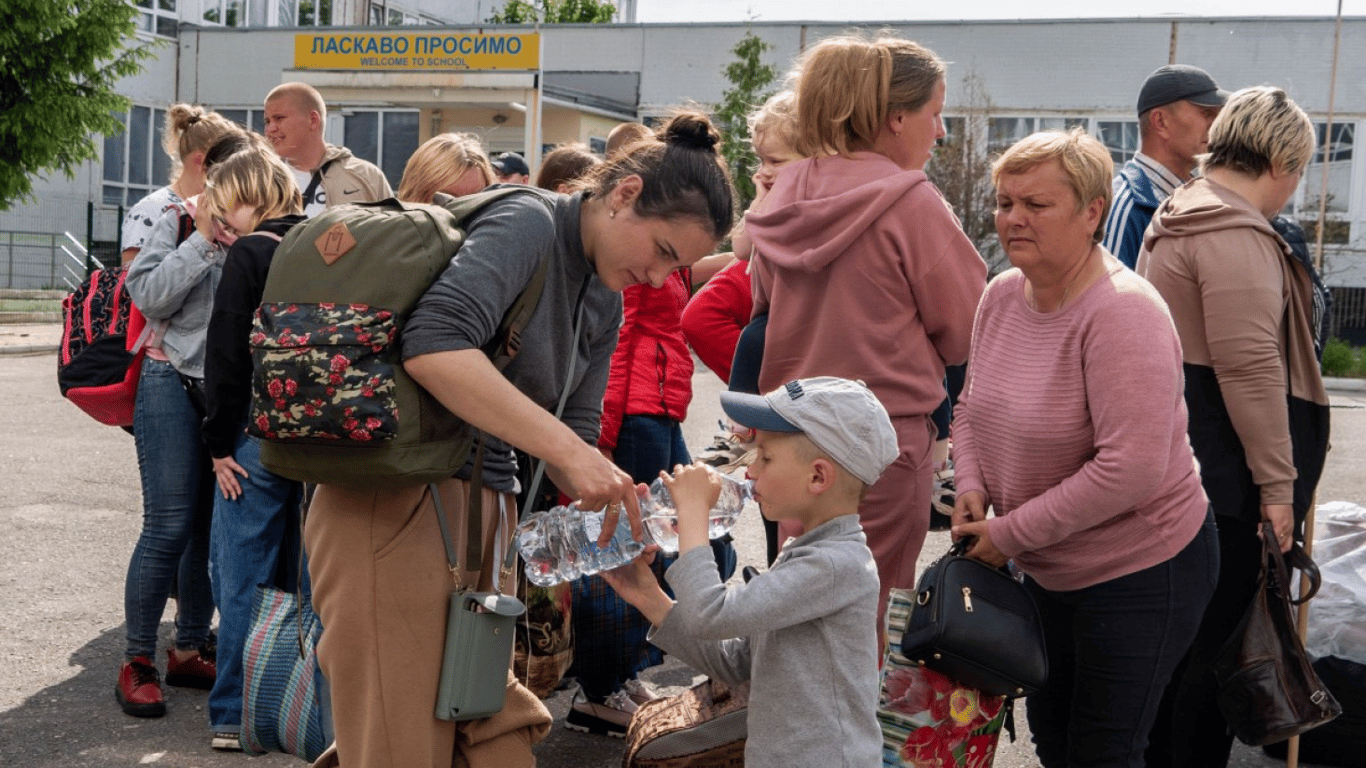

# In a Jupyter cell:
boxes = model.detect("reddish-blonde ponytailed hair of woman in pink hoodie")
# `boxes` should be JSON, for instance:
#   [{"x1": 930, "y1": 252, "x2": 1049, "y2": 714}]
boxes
[{"x1": 794, "y1": 31, "x2": 948, "y2": 157}]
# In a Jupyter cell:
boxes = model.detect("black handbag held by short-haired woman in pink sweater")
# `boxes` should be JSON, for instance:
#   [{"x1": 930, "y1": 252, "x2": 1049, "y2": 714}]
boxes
[{"x1": 902, "y1": 538, "x2": 1048, "y2": 697}]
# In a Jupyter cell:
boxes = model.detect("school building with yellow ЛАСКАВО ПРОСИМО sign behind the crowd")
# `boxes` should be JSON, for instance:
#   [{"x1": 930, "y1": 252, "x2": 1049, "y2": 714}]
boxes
[{"x1": 0, "y1": 6, "x2": 1366, "y2": 335}]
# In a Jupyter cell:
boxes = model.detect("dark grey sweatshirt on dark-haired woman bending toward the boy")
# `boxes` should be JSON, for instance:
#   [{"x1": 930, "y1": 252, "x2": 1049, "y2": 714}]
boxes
[{"x1": 403, "y1": 193, "x2": 622, "y2": 491}]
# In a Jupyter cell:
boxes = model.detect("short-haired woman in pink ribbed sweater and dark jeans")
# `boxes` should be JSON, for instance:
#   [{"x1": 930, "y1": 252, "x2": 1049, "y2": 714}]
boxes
[{"x1": 953, "y1": 130, "x2": 1218, "y2": 768}]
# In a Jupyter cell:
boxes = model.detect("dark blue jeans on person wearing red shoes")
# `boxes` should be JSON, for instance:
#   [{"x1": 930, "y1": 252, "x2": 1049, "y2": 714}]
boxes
[{"x1": 123, "y1": 358, "x2": 213, "y2": 660}]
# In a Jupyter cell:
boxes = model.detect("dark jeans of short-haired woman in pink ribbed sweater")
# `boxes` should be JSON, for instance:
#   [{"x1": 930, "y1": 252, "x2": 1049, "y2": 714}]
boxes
[{"x1": 1025, "y1": 515, "x2": 1218, "y2": 768}]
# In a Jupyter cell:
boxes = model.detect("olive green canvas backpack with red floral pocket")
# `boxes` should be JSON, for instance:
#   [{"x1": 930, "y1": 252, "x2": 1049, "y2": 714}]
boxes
[{"x1": 247, "y1": 187, "x2": 555, "y2": 488}]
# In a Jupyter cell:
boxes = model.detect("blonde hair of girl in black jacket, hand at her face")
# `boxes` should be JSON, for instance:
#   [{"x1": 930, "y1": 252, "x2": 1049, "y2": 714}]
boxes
[{"x1": 199, "y1": 146, "x2": 303, "y2": 235}]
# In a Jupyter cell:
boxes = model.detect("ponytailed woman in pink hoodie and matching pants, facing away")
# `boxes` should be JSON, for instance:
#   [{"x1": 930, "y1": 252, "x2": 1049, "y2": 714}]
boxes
[{"x1": 746, "y1": 37, "x2": 986, "y2": 622}]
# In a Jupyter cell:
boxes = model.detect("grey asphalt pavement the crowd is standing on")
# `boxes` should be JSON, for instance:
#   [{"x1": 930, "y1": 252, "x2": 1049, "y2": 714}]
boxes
[{"x1": 0, "y1": 325, "x2": 1366, "y2": 768}]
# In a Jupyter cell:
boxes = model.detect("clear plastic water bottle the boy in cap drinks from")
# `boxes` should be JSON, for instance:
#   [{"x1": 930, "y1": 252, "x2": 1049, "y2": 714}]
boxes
[{"x1": 516, "y1": 474, "x2": 753, "y2": 586}]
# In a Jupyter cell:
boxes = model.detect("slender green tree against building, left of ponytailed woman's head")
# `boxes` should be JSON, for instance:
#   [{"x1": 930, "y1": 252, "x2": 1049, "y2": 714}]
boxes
[{"x1": 716, "y1": 31, "x2": 777, "y2": 210}]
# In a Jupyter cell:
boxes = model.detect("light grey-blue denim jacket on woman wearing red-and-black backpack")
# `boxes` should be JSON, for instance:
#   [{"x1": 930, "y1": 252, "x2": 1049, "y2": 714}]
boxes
[{"x1": 124, "y1": 208, "x2": 227, "y2": 379}]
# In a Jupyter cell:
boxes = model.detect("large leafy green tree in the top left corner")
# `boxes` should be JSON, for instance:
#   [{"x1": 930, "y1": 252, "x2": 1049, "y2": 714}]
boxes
[{"x1": 0, "y1": 0, "x2": 152, "y2": 210}]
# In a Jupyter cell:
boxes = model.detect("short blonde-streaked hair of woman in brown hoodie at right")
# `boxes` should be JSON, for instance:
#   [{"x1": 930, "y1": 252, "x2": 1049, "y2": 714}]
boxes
[{"x1": 1202, "y1": 85, "x2": 1314, "y2": 176}]
